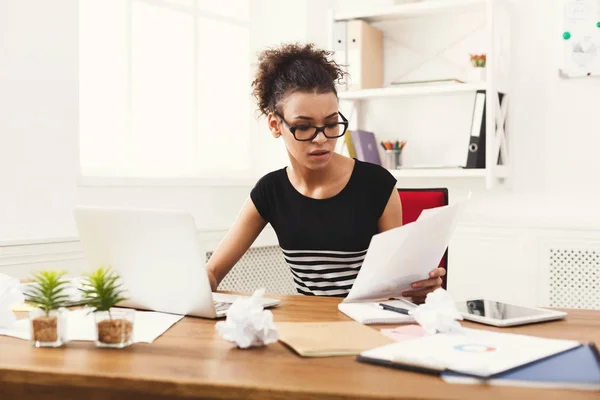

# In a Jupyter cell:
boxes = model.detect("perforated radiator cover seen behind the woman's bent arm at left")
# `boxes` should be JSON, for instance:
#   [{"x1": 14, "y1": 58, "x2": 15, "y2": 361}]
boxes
[{"x1": 206, "y1": 246, "x2": 297, "y2": 294}]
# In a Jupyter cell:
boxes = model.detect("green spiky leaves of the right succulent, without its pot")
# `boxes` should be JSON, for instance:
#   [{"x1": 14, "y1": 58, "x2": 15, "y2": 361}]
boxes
[{"x1": 82, "y1": 267, "x2": 127, "y2": 319}]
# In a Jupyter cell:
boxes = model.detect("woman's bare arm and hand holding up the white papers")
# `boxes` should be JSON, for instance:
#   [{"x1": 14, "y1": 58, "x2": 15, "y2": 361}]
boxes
[{"x1": 377, "y1": 188, "x2": 446, "y2": 303}]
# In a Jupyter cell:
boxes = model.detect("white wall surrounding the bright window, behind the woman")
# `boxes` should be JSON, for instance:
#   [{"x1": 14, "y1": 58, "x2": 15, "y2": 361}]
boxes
[{"x1": 0, "y1": 0, "x2": 338, "y2": 243}]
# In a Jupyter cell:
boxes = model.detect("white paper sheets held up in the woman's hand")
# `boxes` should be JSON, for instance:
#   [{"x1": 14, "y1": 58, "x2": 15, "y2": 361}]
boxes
[{"x1": 344, "y1": 202, "x2": 466, "y2": 302}]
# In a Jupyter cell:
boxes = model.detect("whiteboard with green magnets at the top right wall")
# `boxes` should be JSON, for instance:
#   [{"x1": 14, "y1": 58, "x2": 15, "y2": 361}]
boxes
[{"x1": 559, "y1": 0, "x2": 600, "y2": 78}]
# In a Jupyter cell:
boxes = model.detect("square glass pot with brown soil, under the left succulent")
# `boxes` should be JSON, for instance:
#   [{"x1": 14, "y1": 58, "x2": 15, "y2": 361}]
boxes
[{"x1": 29, "y1": 308, "x2": 68, "y2": 347}]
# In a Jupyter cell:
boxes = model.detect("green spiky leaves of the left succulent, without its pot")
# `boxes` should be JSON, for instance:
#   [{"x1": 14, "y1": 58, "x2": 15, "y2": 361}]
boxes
[{"x1": 25, "y1": 271, "x2": 69, "y2": 316}]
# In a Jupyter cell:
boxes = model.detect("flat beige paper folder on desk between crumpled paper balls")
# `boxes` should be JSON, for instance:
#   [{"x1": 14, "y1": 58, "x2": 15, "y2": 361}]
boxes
[{"x1": 277, "y1": 321, "x2": 393, "y2": 357}]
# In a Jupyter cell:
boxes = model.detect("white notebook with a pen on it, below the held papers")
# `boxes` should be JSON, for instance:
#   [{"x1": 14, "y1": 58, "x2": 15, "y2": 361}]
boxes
[{"x1": 338, "y1": 299, "x2": 416, "y2": 325}]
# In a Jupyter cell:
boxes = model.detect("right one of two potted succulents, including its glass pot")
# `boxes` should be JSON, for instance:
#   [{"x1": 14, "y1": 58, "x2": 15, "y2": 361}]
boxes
[{"x1": 82, "y1": 267, "x2": 135, "y2": 348}]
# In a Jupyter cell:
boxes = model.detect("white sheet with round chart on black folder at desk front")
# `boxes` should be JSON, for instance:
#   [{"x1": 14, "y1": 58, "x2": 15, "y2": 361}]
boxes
[{"x1": 358, "y1": 329, "x2": 581, "y2": 378}]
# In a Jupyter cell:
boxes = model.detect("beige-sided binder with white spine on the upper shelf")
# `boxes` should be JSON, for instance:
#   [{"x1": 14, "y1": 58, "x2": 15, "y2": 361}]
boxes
[{"x1": 346, "y1": 20, "x2": 383, "y2": 90}]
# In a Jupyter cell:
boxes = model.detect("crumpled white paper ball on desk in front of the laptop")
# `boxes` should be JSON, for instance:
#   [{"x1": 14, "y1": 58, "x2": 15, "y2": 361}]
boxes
[{"x1": 215, "y1": 289, "x2": 279, "y2": 349}]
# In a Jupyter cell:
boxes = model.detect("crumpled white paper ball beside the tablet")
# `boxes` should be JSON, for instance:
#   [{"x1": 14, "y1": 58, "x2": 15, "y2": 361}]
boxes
[{"x1": 411, "y1": 288, "x2": 463, "y2": 334}]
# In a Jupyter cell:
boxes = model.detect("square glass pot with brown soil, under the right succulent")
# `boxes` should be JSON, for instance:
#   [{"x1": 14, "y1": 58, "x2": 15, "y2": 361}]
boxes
[{"x1": 94, "y1": 308, "x2": 135, "y2": 349}]
